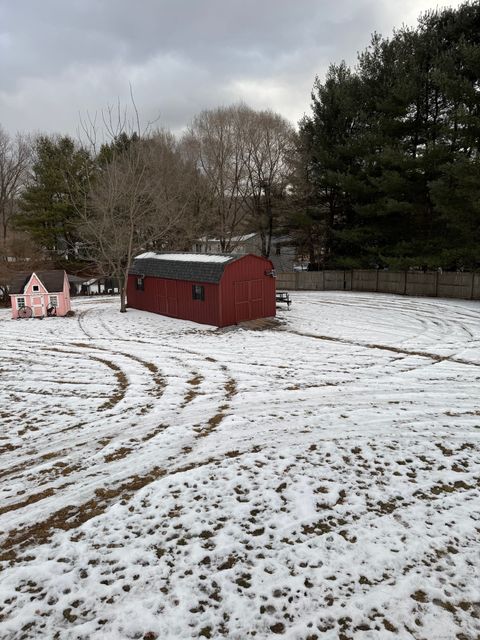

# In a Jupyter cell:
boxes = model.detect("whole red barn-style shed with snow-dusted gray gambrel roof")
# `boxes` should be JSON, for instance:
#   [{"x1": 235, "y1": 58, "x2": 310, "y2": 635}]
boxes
[{"x1": 127, "y1": 252, "x2": 275, "y2": 327}]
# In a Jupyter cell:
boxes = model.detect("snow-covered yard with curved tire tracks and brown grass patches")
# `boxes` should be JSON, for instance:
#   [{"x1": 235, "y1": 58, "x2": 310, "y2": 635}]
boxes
[{"x1": 0, "y1": 293, "x2": 480, "y2": 640}]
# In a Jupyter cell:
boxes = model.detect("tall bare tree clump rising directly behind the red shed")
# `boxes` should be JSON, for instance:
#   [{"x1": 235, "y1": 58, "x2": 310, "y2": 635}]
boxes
[{"x1": 184, "y1": 104, "x2": 295, "y2": 256}]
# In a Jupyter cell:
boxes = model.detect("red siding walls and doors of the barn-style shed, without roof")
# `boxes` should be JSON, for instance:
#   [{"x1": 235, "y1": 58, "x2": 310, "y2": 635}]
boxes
[{"x1": 127, "y1": 255, "x2": 275, "y2": 327}]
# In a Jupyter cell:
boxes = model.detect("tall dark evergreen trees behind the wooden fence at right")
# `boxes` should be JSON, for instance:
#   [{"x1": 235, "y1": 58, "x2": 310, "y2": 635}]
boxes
[{"x1": 295, "y1": 2, "x2": 480, "y2": 269}]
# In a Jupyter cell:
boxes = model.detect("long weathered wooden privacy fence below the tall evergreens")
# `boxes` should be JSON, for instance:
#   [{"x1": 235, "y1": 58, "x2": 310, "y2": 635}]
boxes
[{"x1": 277, "y1": 269, "x2": 480, "y2": 300}]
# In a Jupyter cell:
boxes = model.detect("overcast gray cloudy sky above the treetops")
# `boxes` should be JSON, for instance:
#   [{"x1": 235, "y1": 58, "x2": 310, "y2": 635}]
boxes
[{"x1": 0, "y1": 0, "x2": 466, "y2": 134}]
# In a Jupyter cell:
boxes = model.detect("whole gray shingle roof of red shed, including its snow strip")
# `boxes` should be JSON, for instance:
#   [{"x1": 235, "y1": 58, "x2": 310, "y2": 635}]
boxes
[{"x1": 130, "y1": 251, "x2": 240, "y2": 284}]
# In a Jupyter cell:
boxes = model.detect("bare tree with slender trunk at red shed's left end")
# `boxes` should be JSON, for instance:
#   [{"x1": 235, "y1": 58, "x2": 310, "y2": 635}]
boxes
[{"x1": 80, "y1": 132, "x2": 196, "y2": 312}]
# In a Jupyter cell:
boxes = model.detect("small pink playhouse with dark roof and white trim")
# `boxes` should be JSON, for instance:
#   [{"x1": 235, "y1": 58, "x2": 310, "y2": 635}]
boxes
[{"x1": 10, "y1": 270, "x2": 70, "y2": 319}]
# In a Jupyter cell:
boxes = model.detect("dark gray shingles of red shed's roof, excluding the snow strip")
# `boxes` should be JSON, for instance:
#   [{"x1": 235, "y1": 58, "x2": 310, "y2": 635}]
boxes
[{"x1": 130, "y1": 253, "x2": 244, "y2": 284}]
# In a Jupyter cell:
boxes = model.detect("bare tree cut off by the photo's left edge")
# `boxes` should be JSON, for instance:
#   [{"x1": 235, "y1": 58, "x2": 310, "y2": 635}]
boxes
[{"x1": 0, "y1": 126, "x2": 32, "y2": 244}]
